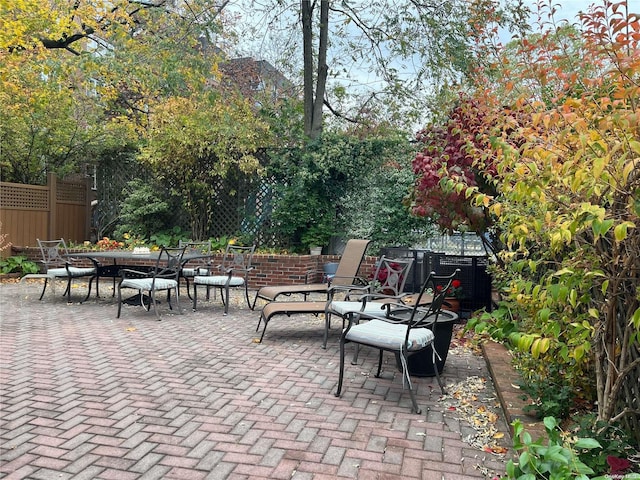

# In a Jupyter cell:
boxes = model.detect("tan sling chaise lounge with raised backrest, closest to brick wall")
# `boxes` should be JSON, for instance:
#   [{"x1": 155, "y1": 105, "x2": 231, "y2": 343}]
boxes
[{"x1": 251, "y1": 239, "x2": 370, "y2": 310}]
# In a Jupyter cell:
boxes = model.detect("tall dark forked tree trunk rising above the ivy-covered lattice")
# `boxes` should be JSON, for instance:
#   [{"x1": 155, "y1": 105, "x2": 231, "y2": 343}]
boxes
[{"x1": 301, "y1": 0, "x2": 329, "y2": 139}]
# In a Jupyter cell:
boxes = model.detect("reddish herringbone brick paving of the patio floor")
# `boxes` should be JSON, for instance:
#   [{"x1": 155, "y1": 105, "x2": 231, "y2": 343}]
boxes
[{"x1": 0, "y1": 283, "x2": 508, "y2": 480}]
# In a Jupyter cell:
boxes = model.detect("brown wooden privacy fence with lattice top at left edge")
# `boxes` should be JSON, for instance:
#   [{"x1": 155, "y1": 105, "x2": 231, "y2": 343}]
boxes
[{"x1": 0, "y1": 174, "x2": 91, "y2": 256}]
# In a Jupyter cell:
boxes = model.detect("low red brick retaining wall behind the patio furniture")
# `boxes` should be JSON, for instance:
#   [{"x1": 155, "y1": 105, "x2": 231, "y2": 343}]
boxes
[{"x1": 13, "y1": 247, "x2": 377, "y2": 289}]
